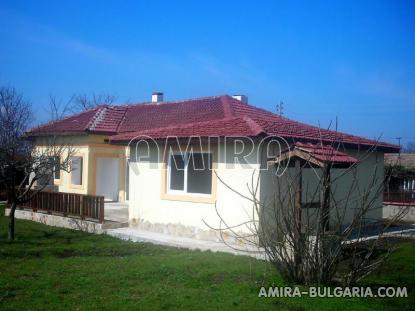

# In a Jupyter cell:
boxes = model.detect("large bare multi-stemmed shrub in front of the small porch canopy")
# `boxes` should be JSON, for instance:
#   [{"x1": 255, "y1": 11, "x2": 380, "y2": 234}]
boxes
[{"x1": 206, "y1": 136, "x2": 408, "y2": 284}]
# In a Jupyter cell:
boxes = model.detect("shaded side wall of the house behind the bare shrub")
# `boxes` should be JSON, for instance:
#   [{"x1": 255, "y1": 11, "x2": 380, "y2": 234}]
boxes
[{"x1": 261, "y1": 150, "x2": 384, "y2": 228}]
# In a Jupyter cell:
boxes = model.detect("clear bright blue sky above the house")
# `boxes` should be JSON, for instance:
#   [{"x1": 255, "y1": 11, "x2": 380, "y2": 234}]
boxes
[{"x1": 0, "y1": 0, "x2": 415, "y2": 147}]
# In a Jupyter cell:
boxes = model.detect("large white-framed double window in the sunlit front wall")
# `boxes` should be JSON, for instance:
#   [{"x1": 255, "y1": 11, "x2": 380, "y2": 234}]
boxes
[{"x1": 168, "y1": 153, "x2": 212, "y2": 195}]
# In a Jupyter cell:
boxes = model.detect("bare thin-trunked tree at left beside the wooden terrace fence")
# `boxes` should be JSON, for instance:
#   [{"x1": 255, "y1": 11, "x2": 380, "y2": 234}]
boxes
[{"x1": 0, "y1": 87, "x2": 73, "y2": 240}]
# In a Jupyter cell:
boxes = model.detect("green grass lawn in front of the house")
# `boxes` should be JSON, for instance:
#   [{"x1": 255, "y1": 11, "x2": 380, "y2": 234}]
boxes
[{"x1": 0, "y1": 206, "x2": 415, "y2": 310}]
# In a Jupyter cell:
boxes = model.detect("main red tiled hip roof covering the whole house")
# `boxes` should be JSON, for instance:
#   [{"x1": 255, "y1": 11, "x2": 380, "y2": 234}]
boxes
[{"x1": 25, "y1": 95, "x2": 399, "y2": 152}]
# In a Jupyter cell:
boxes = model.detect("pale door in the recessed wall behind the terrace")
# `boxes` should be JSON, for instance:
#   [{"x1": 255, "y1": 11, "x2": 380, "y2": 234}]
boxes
[{"x1": 96, "y1": 158, "x2": 119, "y2": 201}]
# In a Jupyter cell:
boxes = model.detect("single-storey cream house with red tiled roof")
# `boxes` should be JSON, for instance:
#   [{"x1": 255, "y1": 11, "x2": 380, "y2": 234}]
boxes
[{"x1": 29, "y1": 93, "x2": 399, "y2": 239}]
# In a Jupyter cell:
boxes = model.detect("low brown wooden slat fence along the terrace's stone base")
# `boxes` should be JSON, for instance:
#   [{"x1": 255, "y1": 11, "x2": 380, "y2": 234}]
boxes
[{"x1": 19, "y1": 190, "x2": 104, "y2": 223}]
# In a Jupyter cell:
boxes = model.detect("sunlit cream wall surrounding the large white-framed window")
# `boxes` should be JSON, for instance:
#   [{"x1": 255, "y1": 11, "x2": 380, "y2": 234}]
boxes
[{"x1": 129, "y1": 140, "x2": 259, "y2": 240}]
